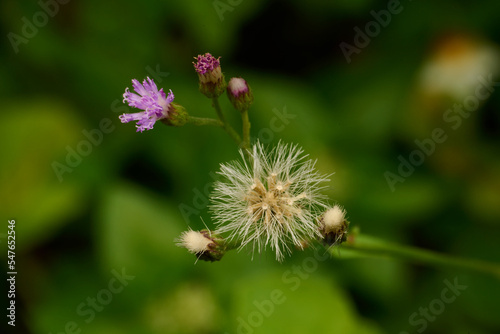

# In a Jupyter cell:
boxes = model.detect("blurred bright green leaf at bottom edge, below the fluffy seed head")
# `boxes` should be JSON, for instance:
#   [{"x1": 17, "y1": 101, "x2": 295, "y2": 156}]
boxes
[{"x1": 231, "y1": 268, "x2": 379, "y2": 334}]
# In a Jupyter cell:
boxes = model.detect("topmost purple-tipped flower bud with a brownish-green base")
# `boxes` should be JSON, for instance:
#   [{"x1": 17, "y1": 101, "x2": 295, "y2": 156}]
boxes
[{"x1": 193, "y1": 52, "x2": 227, "y2": 98}]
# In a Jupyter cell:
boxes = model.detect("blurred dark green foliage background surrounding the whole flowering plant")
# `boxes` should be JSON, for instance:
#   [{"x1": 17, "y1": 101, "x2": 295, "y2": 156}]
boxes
[{"x1": 0, "y1": 0, "x2": 500, "y2": 334}]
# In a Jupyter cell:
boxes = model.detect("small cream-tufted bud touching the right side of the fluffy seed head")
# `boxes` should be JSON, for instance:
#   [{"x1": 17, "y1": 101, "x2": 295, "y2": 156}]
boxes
[{"x1": 319, "y1": 205, "x2": 349, "y2": 246}]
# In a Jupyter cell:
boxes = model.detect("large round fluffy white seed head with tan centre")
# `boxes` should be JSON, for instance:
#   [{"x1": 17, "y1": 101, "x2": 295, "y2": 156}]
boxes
[{"x1": 211, "y1": 143, "x2": 328, "y2": 261}]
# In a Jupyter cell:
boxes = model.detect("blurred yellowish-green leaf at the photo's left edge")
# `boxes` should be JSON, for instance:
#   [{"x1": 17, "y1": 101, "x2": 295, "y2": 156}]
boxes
[{"x1": 0, "y1": 100, "x2": 85, "y2": 248}]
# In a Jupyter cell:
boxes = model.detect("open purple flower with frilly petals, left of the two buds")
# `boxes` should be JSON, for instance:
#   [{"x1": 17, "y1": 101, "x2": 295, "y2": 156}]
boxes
[{"x1": 119, "y1": 77, "x2": 174, "y2": 132}]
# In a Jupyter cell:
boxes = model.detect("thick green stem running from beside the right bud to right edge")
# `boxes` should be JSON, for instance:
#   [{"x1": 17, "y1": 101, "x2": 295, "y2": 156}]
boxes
[{"x1": 330, "y1": 232, "x2": 500, "y2": 279}]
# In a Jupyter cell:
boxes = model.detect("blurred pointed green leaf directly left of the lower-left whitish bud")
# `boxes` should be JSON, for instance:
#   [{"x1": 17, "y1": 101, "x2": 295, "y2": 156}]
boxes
[{"x1": 97, "y1": 184, "x2": 196, "y2": 288}]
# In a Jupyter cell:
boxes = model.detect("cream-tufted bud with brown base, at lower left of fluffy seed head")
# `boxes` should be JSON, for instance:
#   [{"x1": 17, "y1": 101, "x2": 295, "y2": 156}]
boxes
[{"x1": 177, "y1": 230, "x2": 226, "y2": 262}]
